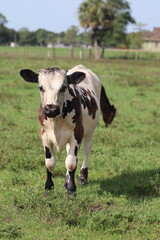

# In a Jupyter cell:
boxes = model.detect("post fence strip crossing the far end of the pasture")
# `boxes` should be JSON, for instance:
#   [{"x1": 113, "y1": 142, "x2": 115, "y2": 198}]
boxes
[{"x1": 0, "y1": 46, "x2": 160, "y2": 60}]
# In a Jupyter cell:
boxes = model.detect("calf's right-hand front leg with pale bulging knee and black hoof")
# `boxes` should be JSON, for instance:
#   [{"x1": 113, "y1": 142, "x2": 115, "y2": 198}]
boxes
[{"x1": 64, "y1": 142, "x2": 79, "y2": 195}]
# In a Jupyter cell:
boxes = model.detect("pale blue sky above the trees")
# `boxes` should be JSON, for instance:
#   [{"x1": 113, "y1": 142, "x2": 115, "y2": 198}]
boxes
[{"x1": 0, "y1": 0, "x2": 160, "y2": 33}]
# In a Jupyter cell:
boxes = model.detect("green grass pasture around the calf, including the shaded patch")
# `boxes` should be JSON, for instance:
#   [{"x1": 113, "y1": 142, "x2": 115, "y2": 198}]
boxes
[{"x1": 0, "y1": 55, "x2": 160, "y2": 240}]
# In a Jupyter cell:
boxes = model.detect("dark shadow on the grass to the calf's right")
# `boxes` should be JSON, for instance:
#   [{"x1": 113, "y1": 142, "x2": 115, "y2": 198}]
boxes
[{"x1": 91, "y1": 169, "x2": 160, "y2": 199}]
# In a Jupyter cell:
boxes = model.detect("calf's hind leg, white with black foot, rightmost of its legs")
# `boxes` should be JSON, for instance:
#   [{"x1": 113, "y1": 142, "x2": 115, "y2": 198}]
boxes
[{"x1": 78, "y1": 134, "x2": 92, "y2": 184}]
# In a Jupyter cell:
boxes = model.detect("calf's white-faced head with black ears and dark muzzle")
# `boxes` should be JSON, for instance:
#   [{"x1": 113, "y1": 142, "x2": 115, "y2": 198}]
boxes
[{"x1": 20, "y1": 68, "x2": 85, "y2": 118}]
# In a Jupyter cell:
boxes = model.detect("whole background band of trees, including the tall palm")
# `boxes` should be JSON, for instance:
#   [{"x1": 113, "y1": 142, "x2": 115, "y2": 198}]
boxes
[{"x1": 0, "y1": 0, "x2": 143, "y2": 58}]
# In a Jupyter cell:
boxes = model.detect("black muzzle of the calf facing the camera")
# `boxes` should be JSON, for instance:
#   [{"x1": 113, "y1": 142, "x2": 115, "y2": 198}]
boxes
[{"x1": 43, "y1": 104, "x2": 60, "y2": 118}]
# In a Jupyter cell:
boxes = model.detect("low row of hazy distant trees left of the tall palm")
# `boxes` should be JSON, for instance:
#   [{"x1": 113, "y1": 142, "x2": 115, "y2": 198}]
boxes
[{"x1": 0, "y1": 20, "x2": 83, "y2": 46}]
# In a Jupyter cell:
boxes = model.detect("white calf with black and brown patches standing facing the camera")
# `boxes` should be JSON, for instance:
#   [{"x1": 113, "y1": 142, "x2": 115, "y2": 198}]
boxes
[{"x1": 20, "y1": 65, "x2": 116, "y2": 193}]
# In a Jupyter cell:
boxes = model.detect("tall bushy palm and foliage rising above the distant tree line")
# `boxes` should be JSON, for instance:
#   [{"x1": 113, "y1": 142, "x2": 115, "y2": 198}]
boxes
[{"x1": 79, "y1": 0, "x2": 135, "y2": 59}]
